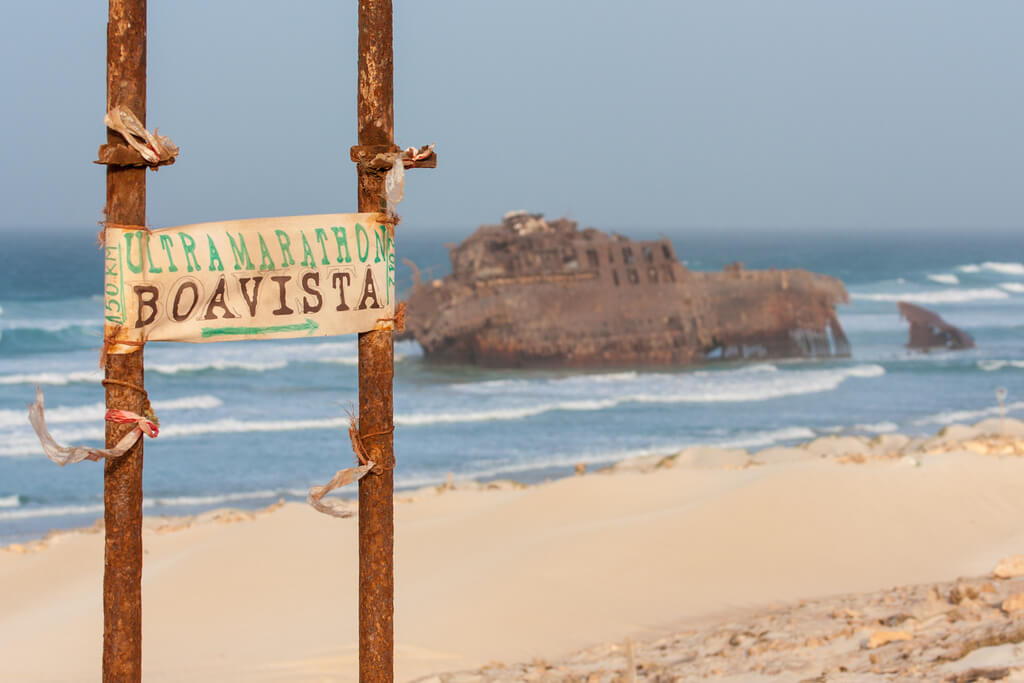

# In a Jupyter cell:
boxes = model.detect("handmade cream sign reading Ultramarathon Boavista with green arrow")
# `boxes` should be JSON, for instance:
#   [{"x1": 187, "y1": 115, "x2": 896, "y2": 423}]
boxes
[{"x1": 103, "y1": 213, "x2": 395, "y2": 353}]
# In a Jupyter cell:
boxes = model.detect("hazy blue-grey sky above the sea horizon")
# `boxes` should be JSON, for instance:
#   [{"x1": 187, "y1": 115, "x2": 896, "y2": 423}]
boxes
[{"x1": 0, "y1": 0, "x2": 1024, "y2": 231}]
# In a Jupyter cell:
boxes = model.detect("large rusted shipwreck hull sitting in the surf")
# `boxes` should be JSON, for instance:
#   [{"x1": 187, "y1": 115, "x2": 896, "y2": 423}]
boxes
[{"x1": 407, "y1": 211, "x2": 850, "y2": 368}]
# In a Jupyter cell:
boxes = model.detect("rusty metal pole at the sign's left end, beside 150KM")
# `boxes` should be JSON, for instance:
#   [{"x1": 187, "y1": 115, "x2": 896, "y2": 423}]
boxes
[{"x1": 103, "y1": 0, "x2": 146, "y2": 683}]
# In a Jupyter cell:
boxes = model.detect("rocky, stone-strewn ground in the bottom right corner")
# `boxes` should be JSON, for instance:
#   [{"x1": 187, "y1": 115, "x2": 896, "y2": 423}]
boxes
[{"x1": 417, "y1": 555, "x2": 1024, "y2": 683}]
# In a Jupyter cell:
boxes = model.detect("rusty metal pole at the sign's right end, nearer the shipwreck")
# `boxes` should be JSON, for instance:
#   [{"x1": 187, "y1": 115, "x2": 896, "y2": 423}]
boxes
[{"x1": 357, "y1": 0, "x2": 400, "y2": 683}]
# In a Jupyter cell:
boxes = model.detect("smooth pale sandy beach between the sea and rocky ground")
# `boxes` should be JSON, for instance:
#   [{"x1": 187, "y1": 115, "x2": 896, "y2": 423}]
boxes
[{"x1": 0, "y1": 420, "x2": 1024, "y2": 681}]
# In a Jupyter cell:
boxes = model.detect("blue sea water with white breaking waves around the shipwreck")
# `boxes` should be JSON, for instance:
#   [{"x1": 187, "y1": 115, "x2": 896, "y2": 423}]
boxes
[{"x1": 0, "y1": 224, "x2": 1024, "y2": 544}]
